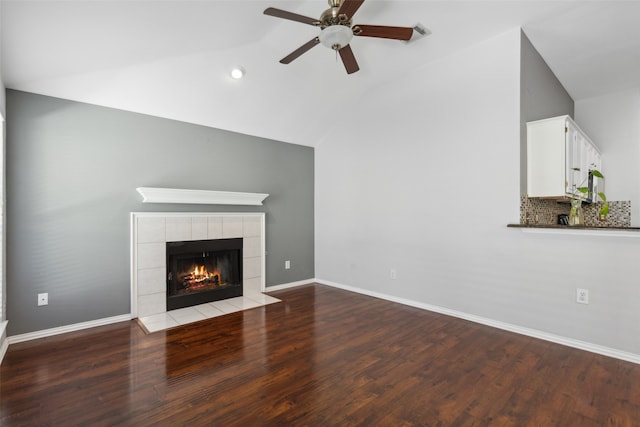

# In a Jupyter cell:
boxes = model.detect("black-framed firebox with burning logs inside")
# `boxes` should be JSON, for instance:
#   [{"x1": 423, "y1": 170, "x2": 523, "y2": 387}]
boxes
[{"x1": 166, "y1": 238, "x2": 243, "y2": 311}]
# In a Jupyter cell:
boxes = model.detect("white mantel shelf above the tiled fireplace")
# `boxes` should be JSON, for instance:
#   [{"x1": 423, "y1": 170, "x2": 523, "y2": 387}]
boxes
[{"x1": 136, "y1": 187, "x2": 269, "y2": 206}]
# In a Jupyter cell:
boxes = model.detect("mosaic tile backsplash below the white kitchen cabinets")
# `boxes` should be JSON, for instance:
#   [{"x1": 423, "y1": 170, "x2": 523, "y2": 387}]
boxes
[{"x1": 520, "y1": 195, "x2": 631, "y2": 227}]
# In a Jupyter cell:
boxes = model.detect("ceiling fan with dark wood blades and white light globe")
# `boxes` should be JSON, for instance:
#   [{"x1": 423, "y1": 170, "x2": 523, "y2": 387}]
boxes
[{"x1": 264, "y1": 0, "x2": 413, "y2": 74}]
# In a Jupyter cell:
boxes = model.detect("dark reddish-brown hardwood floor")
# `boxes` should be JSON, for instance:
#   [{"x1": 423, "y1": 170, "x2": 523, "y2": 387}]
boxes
[{"x1": 0, "y1": 285, "x2": 640, "y2": 426}]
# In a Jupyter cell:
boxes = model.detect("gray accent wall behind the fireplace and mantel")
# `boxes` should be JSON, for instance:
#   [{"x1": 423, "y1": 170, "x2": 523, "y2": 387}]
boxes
[{"x1": 6, "y1": 90, "x2": 314, "y2": 336}]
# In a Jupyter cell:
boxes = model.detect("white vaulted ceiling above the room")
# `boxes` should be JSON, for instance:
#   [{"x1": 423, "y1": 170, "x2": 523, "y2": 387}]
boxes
[{"x1": 0, "y1": 0, "x2": 640, "y2": 146}]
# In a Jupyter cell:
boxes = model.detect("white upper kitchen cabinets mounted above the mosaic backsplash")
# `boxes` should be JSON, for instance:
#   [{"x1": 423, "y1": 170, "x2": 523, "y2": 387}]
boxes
[{"x1": 527, "y1": 116, "x2": 602, "y2": 200}]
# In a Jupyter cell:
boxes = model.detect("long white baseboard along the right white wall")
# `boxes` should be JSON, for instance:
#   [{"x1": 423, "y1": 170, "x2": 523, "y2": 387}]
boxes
[{"x1": 316, "y1": 279, "x2": 640, "y2": 364}]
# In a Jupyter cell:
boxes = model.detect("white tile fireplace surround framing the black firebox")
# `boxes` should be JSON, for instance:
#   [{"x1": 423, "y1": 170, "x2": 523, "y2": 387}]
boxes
[{"x1": 131, "y1": 212, "x2": 272, "y2": 332}]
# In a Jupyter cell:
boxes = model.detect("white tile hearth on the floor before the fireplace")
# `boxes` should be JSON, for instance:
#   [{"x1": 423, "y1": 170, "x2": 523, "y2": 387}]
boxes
[{"x1": 138, "y1": 293, "x2": 280, "y2": 333}]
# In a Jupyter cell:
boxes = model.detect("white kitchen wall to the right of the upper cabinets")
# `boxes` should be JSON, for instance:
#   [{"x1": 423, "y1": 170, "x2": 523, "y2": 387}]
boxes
[{"x1": 575, "y1": 88, "x2": 640, "y2": 227}]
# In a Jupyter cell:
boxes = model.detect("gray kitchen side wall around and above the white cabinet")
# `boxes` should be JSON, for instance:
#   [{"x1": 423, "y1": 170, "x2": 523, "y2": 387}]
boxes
[{"x1": 520, "y1": 32, "x2": 574, "y2": 194}]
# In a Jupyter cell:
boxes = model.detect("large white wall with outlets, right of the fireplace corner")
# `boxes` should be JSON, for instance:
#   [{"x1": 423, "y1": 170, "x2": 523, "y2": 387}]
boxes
[{"x1": 315, "y1": 30, "x2": 640, "y2": 354}]
